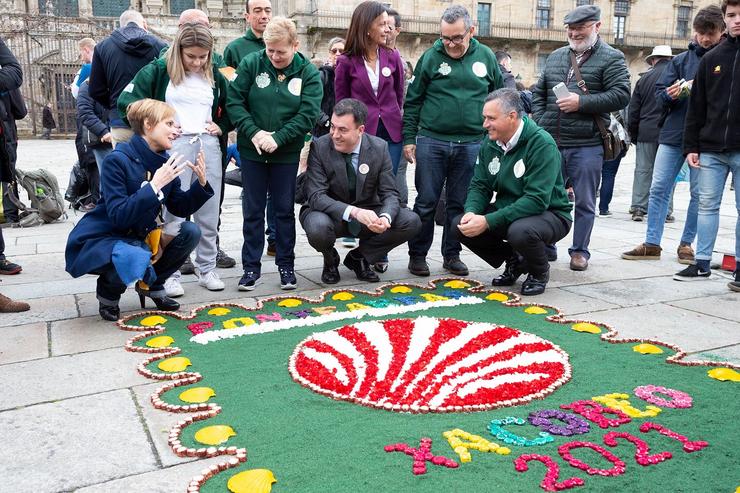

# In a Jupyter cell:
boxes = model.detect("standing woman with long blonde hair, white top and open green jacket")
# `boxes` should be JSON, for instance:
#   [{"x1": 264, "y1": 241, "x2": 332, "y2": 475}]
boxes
[{"x1": 118, "y1": 24, "x2": 230, "y2": 297}]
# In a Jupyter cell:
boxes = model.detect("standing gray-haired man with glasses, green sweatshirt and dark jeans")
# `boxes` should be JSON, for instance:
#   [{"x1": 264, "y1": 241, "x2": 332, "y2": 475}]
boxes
[{"x1": 403, "y1": 5, "x2": 503, "y2": 276}]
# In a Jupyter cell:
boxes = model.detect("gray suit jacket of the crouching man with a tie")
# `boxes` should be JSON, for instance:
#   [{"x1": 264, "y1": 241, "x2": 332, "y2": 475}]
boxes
[{"x1": 304, "y1": 133, "x2": 400, "y2": 222}]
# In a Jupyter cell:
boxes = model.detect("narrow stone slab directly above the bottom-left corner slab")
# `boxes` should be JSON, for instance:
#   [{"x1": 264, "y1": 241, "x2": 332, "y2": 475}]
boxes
[{"x1": 0, "y1": 348, "x2": 147, "y2": 411}]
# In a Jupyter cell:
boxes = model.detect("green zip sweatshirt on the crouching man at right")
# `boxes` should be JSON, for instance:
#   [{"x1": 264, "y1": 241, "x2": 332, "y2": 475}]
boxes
[{"x1": 465, "y1": 117, "x2": 572, "y2": 230}]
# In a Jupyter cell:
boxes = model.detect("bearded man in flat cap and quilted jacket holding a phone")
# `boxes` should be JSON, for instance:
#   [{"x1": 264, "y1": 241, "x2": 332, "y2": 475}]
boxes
[{"x1": 532, "y1": 5, "x2": 630, "y2": 271}]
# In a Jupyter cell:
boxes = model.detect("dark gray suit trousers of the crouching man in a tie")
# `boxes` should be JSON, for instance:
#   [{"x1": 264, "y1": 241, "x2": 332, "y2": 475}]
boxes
[{"x1": 300, "y1": 207, "x2": 421, "y2": 264}]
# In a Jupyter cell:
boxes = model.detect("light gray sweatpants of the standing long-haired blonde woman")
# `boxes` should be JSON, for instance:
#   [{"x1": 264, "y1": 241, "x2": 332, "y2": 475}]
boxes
[{"x1": 164, "y1": 134, "x2": 223, "y2": 278}]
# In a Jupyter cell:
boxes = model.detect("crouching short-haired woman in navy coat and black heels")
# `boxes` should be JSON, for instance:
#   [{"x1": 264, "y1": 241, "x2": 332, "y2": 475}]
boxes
[{"x1": 65, "y1": 99, "x2": 213, "y2": 321}]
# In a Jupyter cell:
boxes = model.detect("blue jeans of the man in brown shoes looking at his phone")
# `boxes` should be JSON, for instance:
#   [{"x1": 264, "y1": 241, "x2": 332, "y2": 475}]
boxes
[{"x1": 645, "y1": 144, "x2": 700, "y2": 245}]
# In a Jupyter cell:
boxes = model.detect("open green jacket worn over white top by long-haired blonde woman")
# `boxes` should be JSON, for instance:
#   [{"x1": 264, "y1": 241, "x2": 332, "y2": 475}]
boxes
[{"x1": 118, "y1": 58, "x2": 233, "y2": 135}]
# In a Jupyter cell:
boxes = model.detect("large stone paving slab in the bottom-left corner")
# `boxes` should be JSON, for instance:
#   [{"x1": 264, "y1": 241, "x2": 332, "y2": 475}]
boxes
[{"x1": 0, "y1": 390, "x2": 156, "y2": 493}]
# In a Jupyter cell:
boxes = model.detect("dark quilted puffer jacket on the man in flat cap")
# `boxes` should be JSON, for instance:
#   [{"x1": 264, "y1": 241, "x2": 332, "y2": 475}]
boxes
[{"x1": 532, "y1": 38, "x2": 630, "y2": 147}]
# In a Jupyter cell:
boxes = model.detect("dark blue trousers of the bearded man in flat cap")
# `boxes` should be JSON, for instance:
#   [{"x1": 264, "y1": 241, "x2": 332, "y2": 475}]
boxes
[{"x1": 560, "y1": 145, "x2": 604, "y2": 258}]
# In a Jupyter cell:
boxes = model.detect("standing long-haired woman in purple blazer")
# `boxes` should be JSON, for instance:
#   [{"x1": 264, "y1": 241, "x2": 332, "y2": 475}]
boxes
[{"x1": 334, "y1": 1, "x2": 404, "y2": 174}]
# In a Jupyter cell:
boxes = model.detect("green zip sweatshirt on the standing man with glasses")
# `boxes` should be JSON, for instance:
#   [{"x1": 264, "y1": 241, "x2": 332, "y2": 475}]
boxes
[{"x1": 403, "y1": 38, "x2": 503, "y2": 144}]
